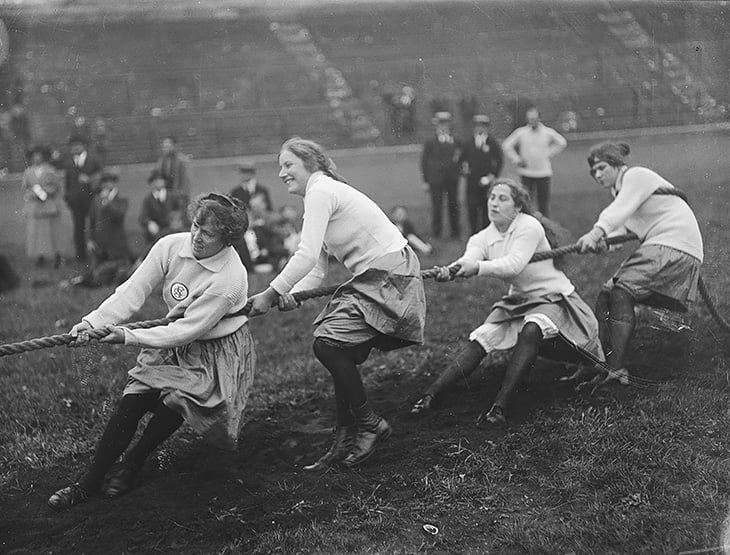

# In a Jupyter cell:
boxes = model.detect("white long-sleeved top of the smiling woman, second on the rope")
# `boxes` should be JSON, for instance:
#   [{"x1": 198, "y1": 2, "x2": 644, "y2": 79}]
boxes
[{"x1": 271, "y1": 172, "x2": 408, "y2": 294}]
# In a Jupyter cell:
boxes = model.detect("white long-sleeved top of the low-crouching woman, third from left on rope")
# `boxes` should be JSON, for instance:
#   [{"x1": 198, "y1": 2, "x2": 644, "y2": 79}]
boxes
[{"x1": 456, "y1": 213, "x2": 575, "y2": 297}]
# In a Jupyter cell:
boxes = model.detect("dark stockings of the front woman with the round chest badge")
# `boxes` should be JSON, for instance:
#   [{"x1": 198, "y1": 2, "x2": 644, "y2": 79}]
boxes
[{"x1": 80, "y1": 391, "x2": 183, "y2": 492}]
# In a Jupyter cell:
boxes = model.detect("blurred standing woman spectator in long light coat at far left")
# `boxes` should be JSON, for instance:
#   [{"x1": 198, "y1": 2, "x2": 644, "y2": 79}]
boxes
[{"x1": 21, "y1": 145, "x2": 61, "y2": 268}]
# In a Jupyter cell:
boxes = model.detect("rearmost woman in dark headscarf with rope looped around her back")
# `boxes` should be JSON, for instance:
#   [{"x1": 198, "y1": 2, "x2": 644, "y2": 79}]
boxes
[{"x1": 578, "y1": 142, "x2": 703, "y2": 380}]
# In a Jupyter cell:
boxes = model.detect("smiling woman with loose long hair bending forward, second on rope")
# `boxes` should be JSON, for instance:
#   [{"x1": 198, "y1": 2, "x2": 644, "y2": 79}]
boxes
[{"x1": 250, "y1": 137, "x2": 426, "y2": 470}]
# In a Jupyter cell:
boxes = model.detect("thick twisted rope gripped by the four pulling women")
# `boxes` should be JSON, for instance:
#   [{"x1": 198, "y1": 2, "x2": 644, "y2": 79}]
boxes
[{"x1": 0, "y1": 233, "x2": 636, "y2": 357}]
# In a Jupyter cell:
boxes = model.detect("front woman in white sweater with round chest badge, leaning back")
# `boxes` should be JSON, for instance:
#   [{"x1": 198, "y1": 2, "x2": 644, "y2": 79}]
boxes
[{"x1": 48, "y1": 193, "x2": 255, "y2": 510}]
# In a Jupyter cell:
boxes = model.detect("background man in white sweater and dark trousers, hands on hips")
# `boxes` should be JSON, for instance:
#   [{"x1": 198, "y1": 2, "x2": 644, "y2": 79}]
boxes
[{"x1": 502, "y1": 107, "x2": 568, "y2": 217}]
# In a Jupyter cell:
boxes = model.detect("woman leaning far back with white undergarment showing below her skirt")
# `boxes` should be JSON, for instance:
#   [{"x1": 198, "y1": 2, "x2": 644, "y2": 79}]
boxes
[{"x1": 411, "y1": 178, "x2": 603, "y2": 426}]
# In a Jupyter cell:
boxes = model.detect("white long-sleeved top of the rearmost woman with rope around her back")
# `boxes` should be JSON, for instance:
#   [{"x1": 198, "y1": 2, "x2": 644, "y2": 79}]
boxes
[{"x1": 595, "y1": 166, "x2": 703, "y2": 262}]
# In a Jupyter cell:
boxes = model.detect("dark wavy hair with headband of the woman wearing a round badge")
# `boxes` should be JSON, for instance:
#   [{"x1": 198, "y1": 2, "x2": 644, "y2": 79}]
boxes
[{"x1": 188, "y1": 193, "x2": 248, "y2": 245}]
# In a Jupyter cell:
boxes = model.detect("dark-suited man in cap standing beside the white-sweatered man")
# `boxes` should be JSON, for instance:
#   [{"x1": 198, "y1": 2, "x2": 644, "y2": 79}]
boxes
[{"x1": 459, "y1": 114, "x2": 504, "y2": 235}]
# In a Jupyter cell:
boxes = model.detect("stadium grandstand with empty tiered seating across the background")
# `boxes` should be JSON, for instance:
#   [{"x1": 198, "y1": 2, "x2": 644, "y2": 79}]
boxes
[{"x1": 0, "y1": 0, "x2": 730, "y2": 171}]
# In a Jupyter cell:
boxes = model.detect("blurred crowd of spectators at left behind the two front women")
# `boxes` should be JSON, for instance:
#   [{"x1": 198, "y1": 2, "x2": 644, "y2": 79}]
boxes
[{"x1": 14, "y1": 127, "x2": 301, "y2": 287}]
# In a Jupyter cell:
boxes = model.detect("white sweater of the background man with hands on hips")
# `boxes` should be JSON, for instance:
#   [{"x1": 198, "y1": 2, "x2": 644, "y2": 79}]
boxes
[{"x1": 502, "y1": 123, "x2": 568, "y2": 177}]
